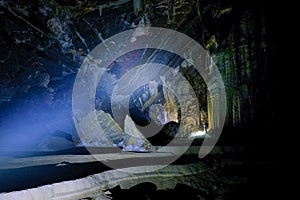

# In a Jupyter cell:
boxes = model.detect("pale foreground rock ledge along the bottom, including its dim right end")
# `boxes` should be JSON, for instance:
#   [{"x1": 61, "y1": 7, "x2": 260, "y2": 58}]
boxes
[{"x1": 0, "y1": 161, "x2": 245, "y2": 199}]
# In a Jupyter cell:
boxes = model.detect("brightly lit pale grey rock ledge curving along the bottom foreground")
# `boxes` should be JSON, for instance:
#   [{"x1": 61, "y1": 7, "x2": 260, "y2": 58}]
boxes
[{"x1": 0, "y1": 163, "x2": 207, "y2": 200}]
